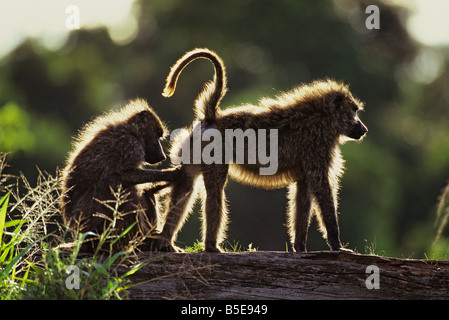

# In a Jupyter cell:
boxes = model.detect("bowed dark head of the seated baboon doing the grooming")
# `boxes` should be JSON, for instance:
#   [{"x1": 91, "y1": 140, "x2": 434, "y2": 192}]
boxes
[{"x1": 132, "y1": 109, "x2": 167, "y2": 164}]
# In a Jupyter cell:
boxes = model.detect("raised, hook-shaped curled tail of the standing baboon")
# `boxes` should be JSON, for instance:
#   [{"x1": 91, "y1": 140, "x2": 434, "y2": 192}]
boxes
[{"x1": 162, "y1": 49, "x2": 227, "y2": 124}]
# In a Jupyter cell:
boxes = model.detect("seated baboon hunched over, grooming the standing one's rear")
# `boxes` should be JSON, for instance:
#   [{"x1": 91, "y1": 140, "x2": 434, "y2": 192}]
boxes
[{"x1": 62, "y1": 99, "x2": 179, "y2": 250}]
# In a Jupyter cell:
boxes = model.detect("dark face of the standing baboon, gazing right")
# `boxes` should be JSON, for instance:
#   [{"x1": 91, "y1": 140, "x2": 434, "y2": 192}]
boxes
[{"x1": 333, "y1": 93, "x2": 368, "y2": 140}]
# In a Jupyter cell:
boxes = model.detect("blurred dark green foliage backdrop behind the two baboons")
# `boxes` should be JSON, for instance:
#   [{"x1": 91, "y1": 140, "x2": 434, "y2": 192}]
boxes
[{"x1": 0, "y1": 0, "x2": 449, "y2": 258}]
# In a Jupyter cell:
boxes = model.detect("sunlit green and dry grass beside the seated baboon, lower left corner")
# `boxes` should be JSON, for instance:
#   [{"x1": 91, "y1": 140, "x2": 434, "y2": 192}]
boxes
[{"x1": 0, "y1": 154, "x2": 143, "y2": 300}]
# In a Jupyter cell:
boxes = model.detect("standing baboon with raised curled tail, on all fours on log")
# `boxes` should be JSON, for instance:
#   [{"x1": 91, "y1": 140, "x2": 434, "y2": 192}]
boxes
[{"x1": 156, "y1": 49, "x2": 368, "y2": 252}]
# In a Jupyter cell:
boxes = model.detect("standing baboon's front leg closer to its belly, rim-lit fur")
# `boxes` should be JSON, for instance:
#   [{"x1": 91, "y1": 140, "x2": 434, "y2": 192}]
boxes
[{"x1": 288, "y1": 179, "x2": 311, "y2": 252}]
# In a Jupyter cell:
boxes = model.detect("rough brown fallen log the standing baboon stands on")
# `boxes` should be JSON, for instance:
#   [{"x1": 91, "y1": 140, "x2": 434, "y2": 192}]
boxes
[{"x1": 121, "y1": 251, "x2": 449, "y2": 300}]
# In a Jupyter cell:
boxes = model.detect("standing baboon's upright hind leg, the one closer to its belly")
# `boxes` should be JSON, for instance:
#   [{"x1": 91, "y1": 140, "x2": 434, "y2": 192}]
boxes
[{"x1": 203, "y1": 166, "x2": 228, "y2": 252}]
